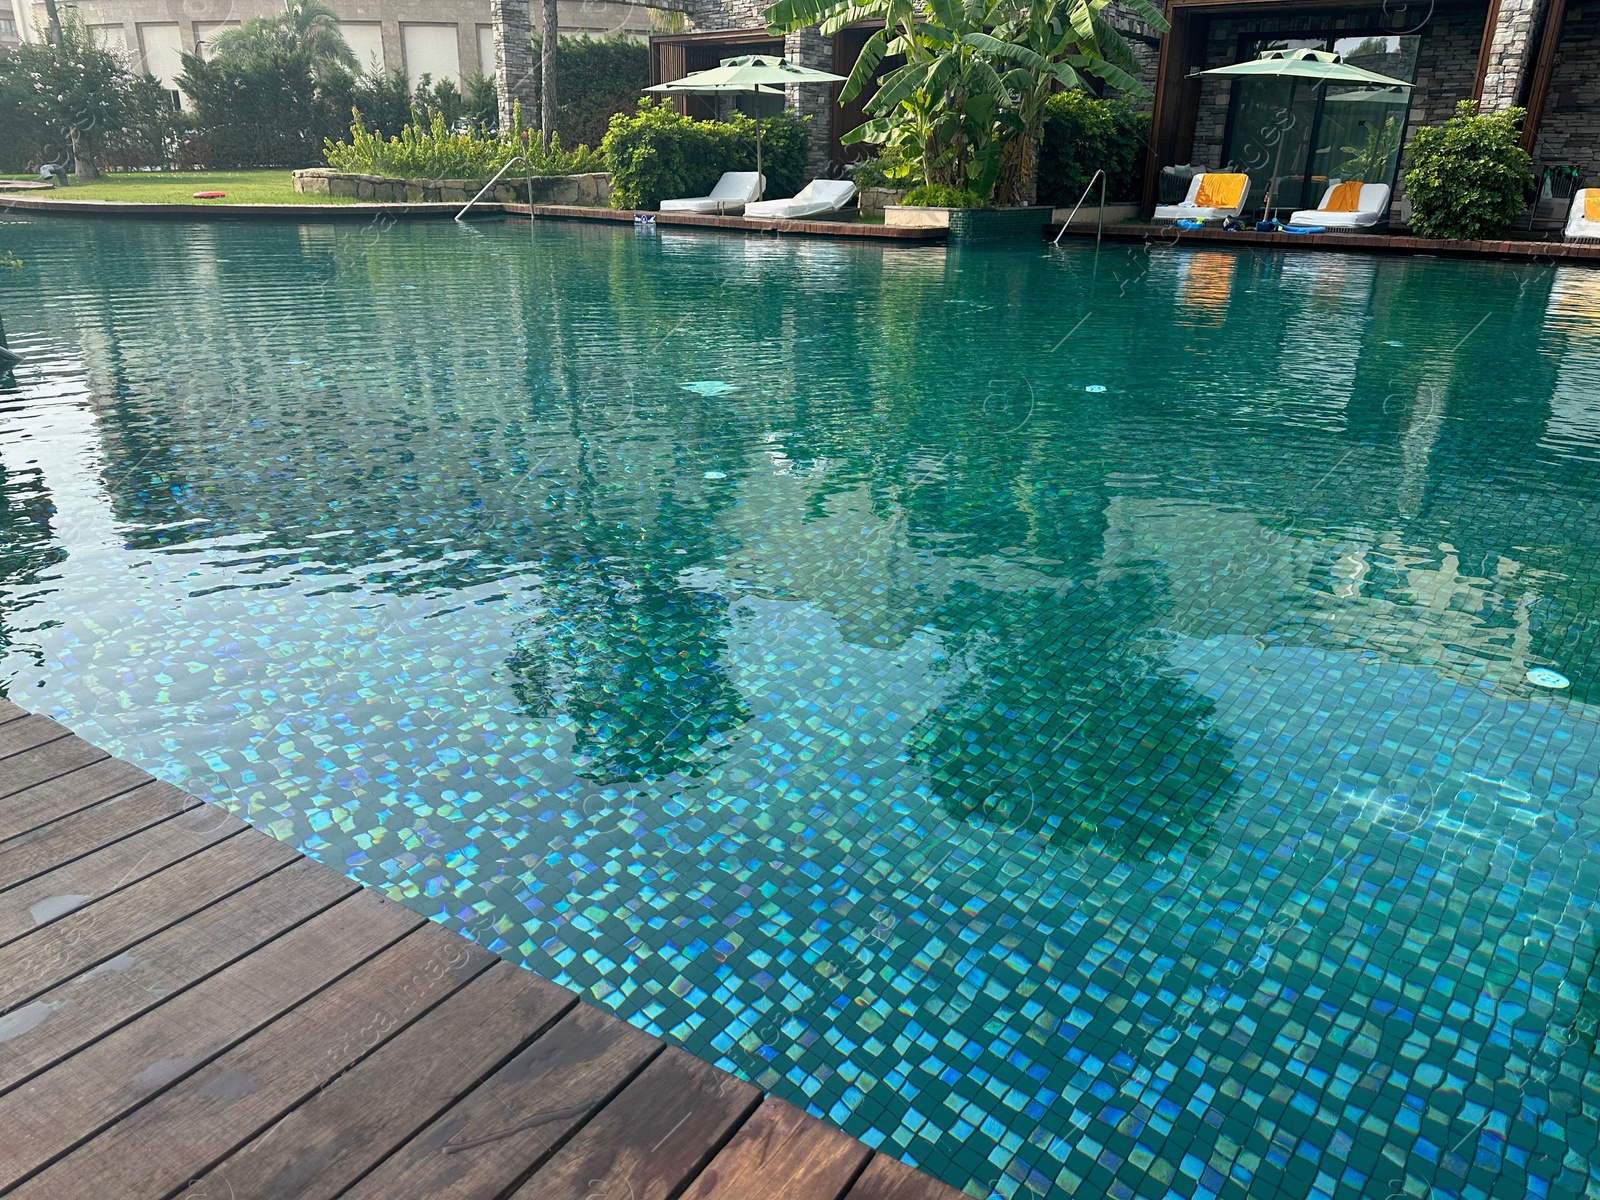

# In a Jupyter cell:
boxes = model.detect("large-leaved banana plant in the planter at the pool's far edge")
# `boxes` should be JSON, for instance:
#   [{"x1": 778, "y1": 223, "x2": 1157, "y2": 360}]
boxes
[{"x1": 766, "y1": 0, "x2": 1166, "y2": 203}]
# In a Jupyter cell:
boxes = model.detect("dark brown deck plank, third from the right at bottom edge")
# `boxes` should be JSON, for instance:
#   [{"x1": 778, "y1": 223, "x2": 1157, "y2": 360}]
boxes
[{"x1": 514, "y1": 1046, "x2": 762, "y2": 1200}]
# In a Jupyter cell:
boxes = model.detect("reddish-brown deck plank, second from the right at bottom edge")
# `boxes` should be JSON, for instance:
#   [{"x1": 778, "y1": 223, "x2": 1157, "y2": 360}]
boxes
[{"x1": 683, "y1": 1096, "x2": 872, "y2": 1200}]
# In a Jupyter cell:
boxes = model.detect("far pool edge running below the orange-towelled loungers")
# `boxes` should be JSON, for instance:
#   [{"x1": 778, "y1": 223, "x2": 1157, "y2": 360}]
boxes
[{"x1": 1045, "y1": 221, "x2": 1600, "y2": 262}]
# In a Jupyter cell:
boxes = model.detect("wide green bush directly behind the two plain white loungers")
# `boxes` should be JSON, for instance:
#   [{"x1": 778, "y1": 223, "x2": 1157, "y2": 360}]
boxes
[{"x1": 600, "y1": 99, "x2": 806, "y2": 208}]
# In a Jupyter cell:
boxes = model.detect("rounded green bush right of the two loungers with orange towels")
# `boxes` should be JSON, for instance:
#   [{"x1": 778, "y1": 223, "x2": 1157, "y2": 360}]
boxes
[{"x1": 1405, "y1": 101, "x2": 1533, "y2": 238}]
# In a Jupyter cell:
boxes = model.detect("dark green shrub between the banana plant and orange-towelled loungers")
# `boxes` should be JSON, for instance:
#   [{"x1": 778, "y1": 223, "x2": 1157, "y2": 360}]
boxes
[{"x1": 1038, "y1": 91, "x2": 1150, "y2": 205}]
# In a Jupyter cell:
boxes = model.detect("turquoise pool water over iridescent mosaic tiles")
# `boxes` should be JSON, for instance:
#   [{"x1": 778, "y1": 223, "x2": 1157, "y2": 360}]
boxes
[{"x1": 0, "y1": 219, "x2": 1600, "y2": 1198}]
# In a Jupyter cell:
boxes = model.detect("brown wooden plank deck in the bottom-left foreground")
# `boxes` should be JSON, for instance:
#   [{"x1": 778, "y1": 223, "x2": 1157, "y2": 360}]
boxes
[{"x1": 0, "y1": 701, "x2": 958, "y2": 1200}]
